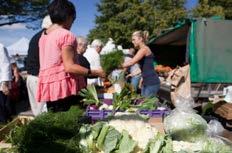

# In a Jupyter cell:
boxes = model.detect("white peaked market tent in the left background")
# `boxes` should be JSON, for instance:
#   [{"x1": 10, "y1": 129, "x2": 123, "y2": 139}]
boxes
[{"x1": 7, "y1": 37, "x2": 29, "y2": 56}]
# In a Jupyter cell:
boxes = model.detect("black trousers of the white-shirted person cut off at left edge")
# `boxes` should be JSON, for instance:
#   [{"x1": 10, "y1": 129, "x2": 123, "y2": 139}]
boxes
[{"x1": 0, "y1": 91, "x2": 11, "y2": 122}]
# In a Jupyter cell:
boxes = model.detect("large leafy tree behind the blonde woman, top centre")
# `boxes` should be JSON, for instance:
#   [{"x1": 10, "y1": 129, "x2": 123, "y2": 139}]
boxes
[{"x1": 88, "y1": 0, "x2": 186, "y2": 47}]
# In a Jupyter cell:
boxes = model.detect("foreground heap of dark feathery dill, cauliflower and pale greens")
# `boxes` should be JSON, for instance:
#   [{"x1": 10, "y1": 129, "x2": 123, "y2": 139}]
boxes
[{"x1": 3, "y1": 108, "x2": 232, "y2": 153}]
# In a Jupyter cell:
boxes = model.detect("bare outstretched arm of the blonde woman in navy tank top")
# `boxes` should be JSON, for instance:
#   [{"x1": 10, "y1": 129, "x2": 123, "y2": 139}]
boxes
[{"x1": 122, "y1": 49, "x2": 146, "y2": 68}]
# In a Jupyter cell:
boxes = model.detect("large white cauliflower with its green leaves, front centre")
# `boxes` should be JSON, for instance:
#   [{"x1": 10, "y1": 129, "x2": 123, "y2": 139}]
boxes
[{"x1": 80, "y1": 114, "x2": 172, "y2": 153}]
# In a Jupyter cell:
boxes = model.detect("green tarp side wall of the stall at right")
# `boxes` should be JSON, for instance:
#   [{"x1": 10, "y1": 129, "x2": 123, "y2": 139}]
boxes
[{"x1": 188, "y1": 19, "x2": 232, "y2": 83}]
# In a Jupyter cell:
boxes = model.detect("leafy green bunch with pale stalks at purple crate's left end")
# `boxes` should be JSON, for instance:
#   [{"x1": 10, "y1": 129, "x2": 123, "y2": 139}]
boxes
[{"x1": 79, "y1": 85, "x2": 101, "y2": 106}]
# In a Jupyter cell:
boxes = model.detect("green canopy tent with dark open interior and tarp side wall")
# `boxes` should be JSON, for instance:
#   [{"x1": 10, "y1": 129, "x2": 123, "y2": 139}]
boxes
[{"x1": 149, "y1": 18, "x2": 232, "y2": 83}]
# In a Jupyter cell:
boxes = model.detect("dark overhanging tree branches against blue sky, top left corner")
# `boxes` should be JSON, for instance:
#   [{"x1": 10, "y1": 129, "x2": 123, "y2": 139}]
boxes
[{"x1": 0, "y1": 0, "x2": 49, "y2": 28}]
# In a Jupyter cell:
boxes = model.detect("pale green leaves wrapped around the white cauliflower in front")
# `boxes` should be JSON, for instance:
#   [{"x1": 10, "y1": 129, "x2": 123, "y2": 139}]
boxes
[{"x1": 79, "y1": 122, "x2": 136, "y2": 153}]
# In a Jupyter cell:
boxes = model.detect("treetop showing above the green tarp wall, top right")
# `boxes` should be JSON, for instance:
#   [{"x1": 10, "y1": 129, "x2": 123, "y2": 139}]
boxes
[{"x1": 193, "y1": 0, "x2": 225, "y2": 18}]
